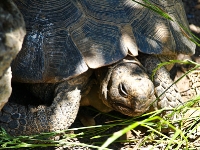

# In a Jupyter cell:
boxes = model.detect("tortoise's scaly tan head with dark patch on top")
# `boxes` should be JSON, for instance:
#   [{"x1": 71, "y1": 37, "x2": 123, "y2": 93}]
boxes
[{"x1": 101, "y1": 60, "x2": 155, "y2": 116}]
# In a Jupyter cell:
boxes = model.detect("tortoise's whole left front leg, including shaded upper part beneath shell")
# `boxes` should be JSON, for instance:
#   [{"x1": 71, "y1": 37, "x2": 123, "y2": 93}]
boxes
[{"x1": 0, "y1": 71, "x2": 88, "y2": 135}]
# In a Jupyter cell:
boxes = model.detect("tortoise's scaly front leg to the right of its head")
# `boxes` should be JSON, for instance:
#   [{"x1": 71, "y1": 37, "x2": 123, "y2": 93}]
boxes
[{"x1": 138, "y1": 55, "x2": 181, "y2": 109}]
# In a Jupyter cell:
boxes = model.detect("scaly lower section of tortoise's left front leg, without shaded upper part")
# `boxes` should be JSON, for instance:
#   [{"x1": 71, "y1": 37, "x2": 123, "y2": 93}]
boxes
[{"x1": 0, "y1": 82, "x2": 81, "y2": 135}]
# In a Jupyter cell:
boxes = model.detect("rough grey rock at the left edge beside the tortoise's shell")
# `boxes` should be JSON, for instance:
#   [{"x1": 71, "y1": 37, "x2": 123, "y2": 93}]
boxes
[{"x1": 0, "y1": 1, "x2": 25, "y2": 110}]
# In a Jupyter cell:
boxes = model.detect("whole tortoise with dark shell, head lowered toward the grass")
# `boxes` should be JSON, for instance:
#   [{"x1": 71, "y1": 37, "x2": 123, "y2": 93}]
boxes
[{"x1": 0, "y1": 0, "x2": 195, "y2": 135}]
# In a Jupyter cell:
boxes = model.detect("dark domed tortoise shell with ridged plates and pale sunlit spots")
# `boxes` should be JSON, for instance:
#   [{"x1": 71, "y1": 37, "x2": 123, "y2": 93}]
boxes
[{"x1": 12, "y1": 0, "x2": 195, "y2": 83}]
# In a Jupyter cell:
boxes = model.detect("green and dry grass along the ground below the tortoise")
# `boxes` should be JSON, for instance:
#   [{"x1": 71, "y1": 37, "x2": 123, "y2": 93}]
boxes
[{"x1": 0, "y1": 97, "x2": 200, "y2": 150}]
